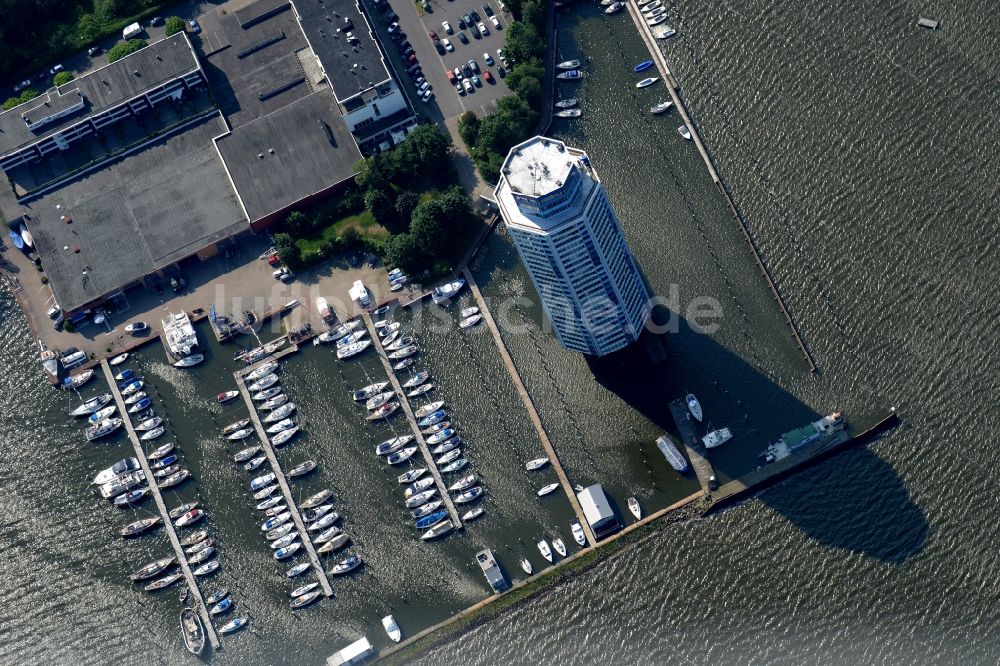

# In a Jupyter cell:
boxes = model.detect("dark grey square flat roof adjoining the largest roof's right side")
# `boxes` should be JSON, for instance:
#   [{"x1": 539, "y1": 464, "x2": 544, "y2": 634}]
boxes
[{"x1": 217, "y1": 88, "x2": 361, "y2": 221}]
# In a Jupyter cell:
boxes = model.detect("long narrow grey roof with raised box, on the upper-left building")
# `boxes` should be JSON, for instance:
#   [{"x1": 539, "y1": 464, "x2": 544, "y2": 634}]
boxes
[{"x1": 0, "y1": 32, "x2": 198, "y2": 155}]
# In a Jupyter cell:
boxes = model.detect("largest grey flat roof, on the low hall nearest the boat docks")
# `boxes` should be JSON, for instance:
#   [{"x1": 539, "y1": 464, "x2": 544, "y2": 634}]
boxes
[{"x1": 24, "y1": 115, "x2": 246, "y2": 310}]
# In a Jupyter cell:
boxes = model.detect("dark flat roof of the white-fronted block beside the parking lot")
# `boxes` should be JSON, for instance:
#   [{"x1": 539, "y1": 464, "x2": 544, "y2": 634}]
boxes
[{"x1": 294, "y1": 0, "x2": 391, "y2": 102}]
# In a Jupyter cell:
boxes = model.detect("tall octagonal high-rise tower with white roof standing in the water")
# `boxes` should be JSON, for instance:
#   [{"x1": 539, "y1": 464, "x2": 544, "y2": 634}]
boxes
[{"x1": 495, "y1": 136, "x2": 649, "y2": 356}]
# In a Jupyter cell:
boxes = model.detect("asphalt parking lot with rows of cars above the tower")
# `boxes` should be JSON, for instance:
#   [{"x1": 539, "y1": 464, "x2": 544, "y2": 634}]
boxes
[{"x1": 365, "y1": 0, "x2": 512, "y2": 121}]
